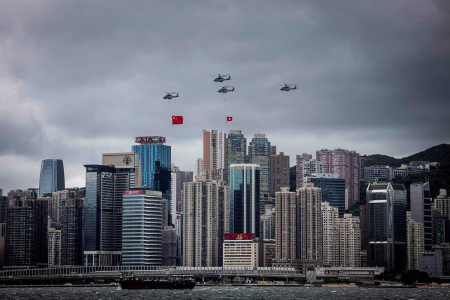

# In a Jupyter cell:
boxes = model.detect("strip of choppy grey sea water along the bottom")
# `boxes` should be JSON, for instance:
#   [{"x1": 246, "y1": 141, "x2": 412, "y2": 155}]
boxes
[{"x1": 0, "y1": 286, "x2": 450, "y2": 300}]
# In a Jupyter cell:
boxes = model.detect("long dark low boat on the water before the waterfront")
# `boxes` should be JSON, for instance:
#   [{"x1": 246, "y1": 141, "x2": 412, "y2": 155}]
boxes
[{"x1": 119, "y1": 273, "x2": 196, "y2": 290}]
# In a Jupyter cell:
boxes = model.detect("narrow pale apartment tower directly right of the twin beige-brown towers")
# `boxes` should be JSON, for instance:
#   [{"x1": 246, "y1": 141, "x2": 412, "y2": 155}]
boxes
[{"x1": 321, "y1": 202, "x2": 340, "y2": 267}]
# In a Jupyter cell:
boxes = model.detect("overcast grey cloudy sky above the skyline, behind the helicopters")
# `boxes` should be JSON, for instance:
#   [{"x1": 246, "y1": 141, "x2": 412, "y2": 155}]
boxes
[{"x1": 0, "y1": 0, "x2": 450, "y2": 195}]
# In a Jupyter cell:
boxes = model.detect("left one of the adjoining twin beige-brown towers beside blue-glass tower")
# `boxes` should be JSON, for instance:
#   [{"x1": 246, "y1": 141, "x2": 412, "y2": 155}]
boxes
[{"x1": 275, "y1": 187, "x2": 300, "y2": 264}]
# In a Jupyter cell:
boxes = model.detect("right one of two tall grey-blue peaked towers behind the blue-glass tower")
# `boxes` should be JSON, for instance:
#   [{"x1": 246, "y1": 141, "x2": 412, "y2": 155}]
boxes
[{"x1": 248, "y1": 133, "x2": 271, "y2": 195}]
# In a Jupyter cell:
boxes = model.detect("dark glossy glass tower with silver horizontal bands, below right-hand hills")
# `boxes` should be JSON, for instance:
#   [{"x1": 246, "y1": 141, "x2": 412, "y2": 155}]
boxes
[{"x1": 366, "y1": 182, "x2": 407, "y2": 272}]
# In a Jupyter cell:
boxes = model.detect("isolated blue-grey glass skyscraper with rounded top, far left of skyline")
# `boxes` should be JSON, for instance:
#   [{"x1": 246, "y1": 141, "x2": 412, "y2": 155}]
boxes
[{"x1": 39, "y1": 159, "x2": 65, "y2": 197}]
